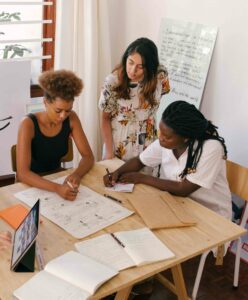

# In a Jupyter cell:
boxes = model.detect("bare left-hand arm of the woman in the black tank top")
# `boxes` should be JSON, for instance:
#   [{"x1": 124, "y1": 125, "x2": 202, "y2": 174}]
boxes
[{"x1": 16, "y1": 118, "x2": 76, "y2": 200}]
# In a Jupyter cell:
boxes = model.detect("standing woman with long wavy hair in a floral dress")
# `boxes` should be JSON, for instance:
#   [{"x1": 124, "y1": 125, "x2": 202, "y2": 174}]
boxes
[{"x1": 99, "y1": 38, "x2": 170, "y2": 161}]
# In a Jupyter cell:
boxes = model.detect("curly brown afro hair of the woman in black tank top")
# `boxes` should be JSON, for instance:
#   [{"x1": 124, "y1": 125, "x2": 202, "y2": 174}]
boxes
[{"x1": 39, "y1": 70, "x2": 83, "y2": 102}]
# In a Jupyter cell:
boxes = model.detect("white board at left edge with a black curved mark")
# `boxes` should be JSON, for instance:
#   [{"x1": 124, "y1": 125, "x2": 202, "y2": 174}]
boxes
[{"x1": 0, "y1": 61, "x2": 31, "y2": 176}]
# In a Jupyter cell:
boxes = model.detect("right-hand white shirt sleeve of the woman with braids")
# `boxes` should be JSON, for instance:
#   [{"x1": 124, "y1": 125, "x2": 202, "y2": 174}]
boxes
[{"x1": 186, "y1": 140, "x2": 224, "y2": 189}]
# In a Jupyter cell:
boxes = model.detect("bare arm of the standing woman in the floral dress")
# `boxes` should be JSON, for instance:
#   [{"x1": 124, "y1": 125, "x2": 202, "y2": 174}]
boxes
[{"x1": 101, "y1": 112, "x2": 115, "y2": 159}]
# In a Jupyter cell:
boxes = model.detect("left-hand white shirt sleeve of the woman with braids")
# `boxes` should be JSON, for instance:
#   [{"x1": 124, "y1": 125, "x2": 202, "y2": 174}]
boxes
[{"x1": 139, "y1": 140, "x2": 162, "y2": 168}]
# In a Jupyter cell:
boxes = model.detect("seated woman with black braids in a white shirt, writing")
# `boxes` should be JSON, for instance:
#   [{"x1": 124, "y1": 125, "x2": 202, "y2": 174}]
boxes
[{"x1": 104, "y1": 101, "x2": 232, "y2": 219}]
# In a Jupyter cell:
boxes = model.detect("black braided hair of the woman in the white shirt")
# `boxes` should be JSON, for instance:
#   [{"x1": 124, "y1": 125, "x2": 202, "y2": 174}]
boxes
[{"x1": 162, "y1": 101, "x2": 227, "y2": 178}]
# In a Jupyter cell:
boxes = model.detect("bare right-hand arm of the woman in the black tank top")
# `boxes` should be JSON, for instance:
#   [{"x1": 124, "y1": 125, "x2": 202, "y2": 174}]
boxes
[{"x1": 66, "y1": 112, "x2": 94, "y2": 187}]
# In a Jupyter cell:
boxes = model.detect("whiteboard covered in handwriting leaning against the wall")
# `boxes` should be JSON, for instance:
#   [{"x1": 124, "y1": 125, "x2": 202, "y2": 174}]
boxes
[{"x1": 157, "y1": 18, "x2": 217, "y2": 122}]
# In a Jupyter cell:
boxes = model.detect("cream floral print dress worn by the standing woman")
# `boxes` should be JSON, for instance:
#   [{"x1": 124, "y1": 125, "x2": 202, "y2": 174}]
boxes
[{"x1": 99, "y1": 66, "x2": 170, "y2": 161}]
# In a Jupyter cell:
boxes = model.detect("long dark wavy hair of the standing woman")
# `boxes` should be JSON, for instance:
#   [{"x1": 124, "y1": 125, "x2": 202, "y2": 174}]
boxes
[{"x1": 113, "y1": 37, "x2": 159, "y2": 105}]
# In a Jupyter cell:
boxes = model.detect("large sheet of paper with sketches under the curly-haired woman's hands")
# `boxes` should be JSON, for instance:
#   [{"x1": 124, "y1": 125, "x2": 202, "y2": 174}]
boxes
[{"x1": 15, "y1": 177, "x2": 133, "y2": 239}]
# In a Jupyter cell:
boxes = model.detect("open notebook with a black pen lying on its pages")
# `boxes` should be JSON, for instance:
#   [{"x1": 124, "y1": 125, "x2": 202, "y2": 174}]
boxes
[{"x1": 75, "y1": 227, "x2": 175, "y2": 271}]
